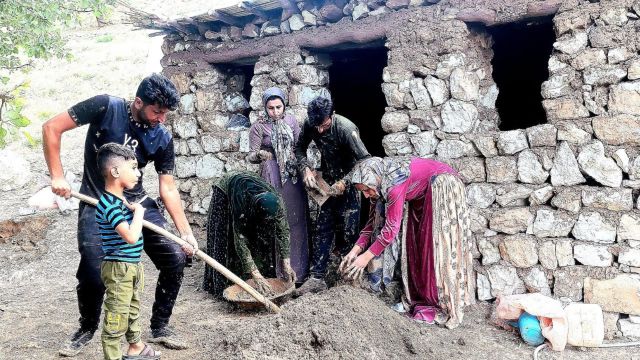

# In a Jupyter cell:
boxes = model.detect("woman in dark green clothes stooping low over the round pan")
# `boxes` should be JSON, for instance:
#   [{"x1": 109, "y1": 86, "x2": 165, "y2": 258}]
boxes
[{"x1": 204, "y1": 172, "x2": 296, "y2": 296}]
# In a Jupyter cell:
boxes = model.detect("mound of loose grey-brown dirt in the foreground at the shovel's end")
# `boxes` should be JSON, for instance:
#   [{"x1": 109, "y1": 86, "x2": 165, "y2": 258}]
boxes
[{"x1": 212, "y1": 286, "x2": 438, "y2": 359}]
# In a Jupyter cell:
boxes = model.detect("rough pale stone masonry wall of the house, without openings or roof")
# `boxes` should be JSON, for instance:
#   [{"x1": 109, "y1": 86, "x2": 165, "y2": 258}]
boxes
[{"x1": 165, "y1": 0, "x2": 640, "y2": 337}]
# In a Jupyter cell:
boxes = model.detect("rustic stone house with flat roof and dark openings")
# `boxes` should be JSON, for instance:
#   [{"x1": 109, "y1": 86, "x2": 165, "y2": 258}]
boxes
[{"x1": 146, "y1": 0, "x2": 640, "y2": 337}]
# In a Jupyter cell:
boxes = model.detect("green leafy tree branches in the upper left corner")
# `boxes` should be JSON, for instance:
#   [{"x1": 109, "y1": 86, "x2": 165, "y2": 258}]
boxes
[{"x1": 0, "y1": 0, "x2": 115, "y2": 147}]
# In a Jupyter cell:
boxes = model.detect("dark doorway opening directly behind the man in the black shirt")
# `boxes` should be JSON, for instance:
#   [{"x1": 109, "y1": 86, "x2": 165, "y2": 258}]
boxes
[{"x1": 329, "y1": 47, "x2": 387, "y2": 157}]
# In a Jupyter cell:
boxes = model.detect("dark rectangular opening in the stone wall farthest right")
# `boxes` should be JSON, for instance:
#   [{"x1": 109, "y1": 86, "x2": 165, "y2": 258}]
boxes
[{"x1": 487, "y1": 16, "x2": 556, "y2": 131}]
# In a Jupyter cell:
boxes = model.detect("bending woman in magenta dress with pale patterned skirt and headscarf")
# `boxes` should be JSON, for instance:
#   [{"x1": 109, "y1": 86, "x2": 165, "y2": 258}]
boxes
[{"x1": 340, "y1": 157, "x2": 475, "y2": 328}]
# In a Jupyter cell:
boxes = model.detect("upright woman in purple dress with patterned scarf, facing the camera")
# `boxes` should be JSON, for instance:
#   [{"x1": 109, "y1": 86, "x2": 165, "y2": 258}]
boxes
[{"x1": 247, "y1": 87, "x2": 309, "y2": 281}]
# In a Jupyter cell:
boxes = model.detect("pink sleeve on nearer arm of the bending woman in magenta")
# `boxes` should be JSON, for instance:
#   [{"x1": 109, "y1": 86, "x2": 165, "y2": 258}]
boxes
[{"x1": 369, "y1": 181, "x2": 408, "y2": 256}]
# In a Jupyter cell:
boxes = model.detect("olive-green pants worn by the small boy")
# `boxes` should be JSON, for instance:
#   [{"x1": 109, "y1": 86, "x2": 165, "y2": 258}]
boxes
[{"x1": 100, "y1": 261, "x2": 144, "y2": 360}]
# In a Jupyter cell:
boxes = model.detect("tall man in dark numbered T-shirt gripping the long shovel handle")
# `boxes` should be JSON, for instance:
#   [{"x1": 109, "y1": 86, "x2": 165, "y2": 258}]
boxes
[{"x1": 42, "y1": 74, "x2": 197, "y2": 356}]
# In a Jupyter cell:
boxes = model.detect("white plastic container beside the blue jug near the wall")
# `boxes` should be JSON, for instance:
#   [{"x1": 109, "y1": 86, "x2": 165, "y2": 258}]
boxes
[{"x1": 564, "y1": 303, "x2": 604, "y2": 347}]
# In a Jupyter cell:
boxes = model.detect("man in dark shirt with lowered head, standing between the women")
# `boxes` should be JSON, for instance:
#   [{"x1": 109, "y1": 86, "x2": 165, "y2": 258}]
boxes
[{"x1": 296, "y1": 97, "x2": 371, "y2": 295}]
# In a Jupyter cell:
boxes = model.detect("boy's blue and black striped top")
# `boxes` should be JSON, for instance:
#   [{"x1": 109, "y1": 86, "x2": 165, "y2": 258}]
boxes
[{"x1": 96, "y1": 191, "x2": 144, "y2": 263}]
